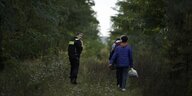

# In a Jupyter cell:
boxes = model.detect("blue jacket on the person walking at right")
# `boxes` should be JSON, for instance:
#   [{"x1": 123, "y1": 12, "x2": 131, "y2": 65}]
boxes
[{"x1": 110, "y1": 45, "x2": 133, "y2": 67}]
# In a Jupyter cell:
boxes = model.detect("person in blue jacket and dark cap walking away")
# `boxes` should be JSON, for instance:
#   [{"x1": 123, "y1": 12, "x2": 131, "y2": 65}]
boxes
[{"x1": 109, "y1": 35, "x2": 133, "y2": 91}]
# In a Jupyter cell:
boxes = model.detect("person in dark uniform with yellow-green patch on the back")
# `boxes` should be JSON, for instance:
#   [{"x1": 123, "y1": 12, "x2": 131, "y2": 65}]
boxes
[{"x1": 68, "y1": 33, "x2": 83, "y2": 84}]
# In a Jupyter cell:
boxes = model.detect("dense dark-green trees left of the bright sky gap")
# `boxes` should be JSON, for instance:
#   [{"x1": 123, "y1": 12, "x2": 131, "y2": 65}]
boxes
[{"x1": 0, "y1": 0, "x2": 98, "y2": 59}]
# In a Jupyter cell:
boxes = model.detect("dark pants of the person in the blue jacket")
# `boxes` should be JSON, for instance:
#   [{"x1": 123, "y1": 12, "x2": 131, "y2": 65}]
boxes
[{"x1": 116, "y1": 67, "x2": 128, "y2": 88}]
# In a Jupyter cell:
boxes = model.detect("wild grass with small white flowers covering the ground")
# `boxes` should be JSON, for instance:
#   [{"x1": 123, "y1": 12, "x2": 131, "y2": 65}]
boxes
[{"x1": 0, "y1": 49, "x2": 141, "y2": 96}]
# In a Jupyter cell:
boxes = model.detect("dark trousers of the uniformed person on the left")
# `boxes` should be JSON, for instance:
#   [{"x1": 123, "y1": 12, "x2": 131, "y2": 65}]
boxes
[{"x1": 69, "y1": 58, "x2": 79, "y2": 81}]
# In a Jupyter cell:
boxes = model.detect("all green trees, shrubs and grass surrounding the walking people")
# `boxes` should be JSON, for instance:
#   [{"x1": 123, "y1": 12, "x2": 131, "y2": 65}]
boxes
[{"x1": 0, "y1": 0, "x2": 192, "y2": 96}]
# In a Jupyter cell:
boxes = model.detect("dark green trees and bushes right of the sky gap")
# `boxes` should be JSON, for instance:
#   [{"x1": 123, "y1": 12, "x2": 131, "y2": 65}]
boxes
[{"x1": 111, "y1": 0, "x2": 192, "y2": 96}]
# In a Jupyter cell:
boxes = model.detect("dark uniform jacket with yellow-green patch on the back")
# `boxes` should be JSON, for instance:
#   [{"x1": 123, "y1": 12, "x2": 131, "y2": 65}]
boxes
[{"x1": 68, "y1": 37, "x2": 83, "y2": 58}]
